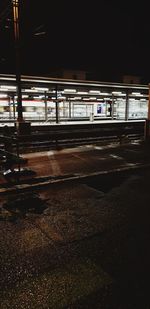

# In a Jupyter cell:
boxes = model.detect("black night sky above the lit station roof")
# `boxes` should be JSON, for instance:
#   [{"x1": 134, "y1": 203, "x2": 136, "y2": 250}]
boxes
[{"x1": 0, "y1": 0, "x2": 150, "y2": 83}]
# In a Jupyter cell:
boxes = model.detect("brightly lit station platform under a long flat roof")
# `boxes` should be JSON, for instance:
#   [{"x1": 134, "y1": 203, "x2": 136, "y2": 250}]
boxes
[{"x1": 0, "y1": 75, "x2": 149, "y2": 123}]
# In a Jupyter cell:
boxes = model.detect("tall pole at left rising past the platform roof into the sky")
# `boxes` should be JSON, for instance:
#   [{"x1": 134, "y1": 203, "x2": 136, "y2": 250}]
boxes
[{"x1": 12, "y1": 0, "x2": 23, "y2": 122}]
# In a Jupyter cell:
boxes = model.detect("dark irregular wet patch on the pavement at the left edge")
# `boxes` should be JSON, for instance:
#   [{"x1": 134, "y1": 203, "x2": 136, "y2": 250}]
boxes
[{"x1": 0, "y1": 193, "x2": 48, "y2": 221}]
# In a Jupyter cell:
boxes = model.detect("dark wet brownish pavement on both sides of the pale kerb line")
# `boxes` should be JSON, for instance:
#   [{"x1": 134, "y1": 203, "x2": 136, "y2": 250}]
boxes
[{"x1": 0, "y1": 140, "x2": 150, "y2": 309}]
